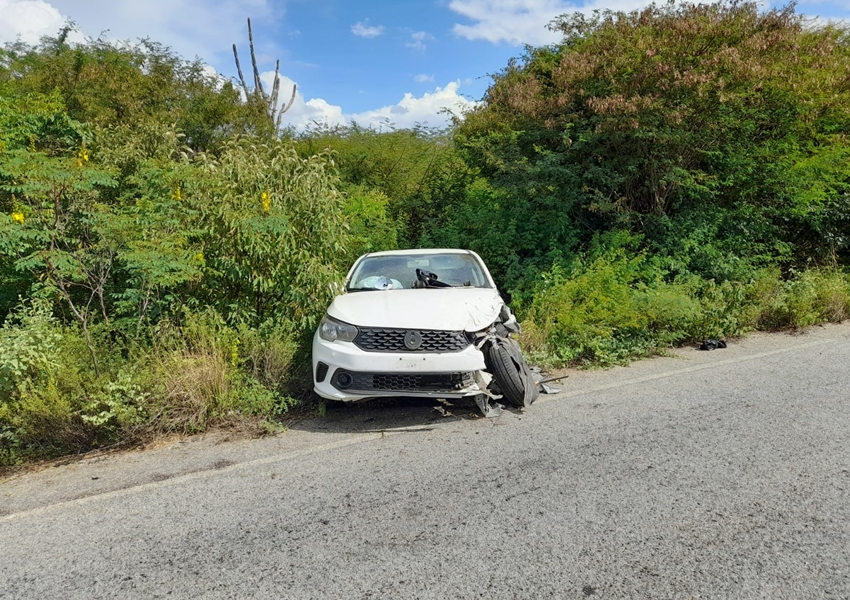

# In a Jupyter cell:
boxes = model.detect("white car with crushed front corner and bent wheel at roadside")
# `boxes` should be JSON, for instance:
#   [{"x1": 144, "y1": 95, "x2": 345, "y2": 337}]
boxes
[{"x1": 313, "y1": 249, "x2": 538, "y2": 416}]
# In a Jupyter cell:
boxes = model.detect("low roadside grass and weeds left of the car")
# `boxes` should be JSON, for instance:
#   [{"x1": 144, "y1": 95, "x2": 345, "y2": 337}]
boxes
[{"x1": 0, "y1": 302, "x2": 301, "y2": 466}]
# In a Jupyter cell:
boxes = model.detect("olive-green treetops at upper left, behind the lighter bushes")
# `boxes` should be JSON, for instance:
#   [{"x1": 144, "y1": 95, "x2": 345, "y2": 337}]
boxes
[{"x1": 0, "y1": 36, "x2": 272, "y2": 151}]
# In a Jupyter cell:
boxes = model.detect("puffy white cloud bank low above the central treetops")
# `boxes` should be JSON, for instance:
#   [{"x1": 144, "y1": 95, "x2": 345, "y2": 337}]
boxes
[{"x1": 261, "y1": 71, "x2": 478, "y2": 131}]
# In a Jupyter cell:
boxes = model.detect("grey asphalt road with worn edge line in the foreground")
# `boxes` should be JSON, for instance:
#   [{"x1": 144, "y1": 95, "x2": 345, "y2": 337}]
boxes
[{"x1": 0, "y1": 325, "x2": 850, "y2": 599}]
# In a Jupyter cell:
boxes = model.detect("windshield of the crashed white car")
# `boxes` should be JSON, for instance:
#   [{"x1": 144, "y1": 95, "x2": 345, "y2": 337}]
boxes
[{"x1": 348, "y1": 253, "x2": 490, "y2": 291}]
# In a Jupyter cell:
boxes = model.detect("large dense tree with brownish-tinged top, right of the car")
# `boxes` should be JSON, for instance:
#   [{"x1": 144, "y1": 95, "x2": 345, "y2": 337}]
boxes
[{"x1": 456, "y1": 2, "x2": 850, "y2": 281}]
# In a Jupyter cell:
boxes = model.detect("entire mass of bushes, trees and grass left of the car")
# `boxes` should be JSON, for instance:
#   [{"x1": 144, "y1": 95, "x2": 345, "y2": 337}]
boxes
[{"x1": 0, "y1": 35, "x2": 344, "y2": 464}]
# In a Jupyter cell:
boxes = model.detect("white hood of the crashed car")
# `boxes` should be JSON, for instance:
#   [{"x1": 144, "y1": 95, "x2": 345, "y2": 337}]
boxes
[{"x1": 328, "y1": 288, "x2": 504, "y2": 331}]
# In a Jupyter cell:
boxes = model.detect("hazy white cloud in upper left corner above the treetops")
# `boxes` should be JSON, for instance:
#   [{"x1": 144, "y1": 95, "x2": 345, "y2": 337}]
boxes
[{"x1": 0, "y1": 0, "x2": 274, "y2": 60}]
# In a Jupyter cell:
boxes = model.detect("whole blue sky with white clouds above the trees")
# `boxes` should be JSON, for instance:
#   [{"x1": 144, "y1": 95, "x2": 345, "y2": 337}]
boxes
[{"x1": 0, "y1": 0, "x2": 850, "y2": 127}]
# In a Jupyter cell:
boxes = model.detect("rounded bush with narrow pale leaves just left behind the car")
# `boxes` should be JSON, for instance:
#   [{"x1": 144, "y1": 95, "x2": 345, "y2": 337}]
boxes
[{"x1": 190, "y1": 139, "x2": 348, "y2": 329}]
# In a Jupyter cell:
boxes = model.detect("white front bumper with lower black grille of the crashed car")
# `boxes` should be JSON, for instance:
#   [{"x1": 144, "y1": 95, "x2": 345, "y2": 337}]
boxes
[{"x1": 313, "y1": 332, "x2": 486, "y2": 402}]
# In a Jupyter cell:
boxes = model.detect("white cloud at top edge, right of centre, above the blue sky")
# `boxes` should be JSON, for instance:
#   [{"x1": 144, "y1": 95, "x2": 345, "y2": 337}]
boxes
[{"x1": 449, "y1": 0, "x2": 651, "y2": 46}]
